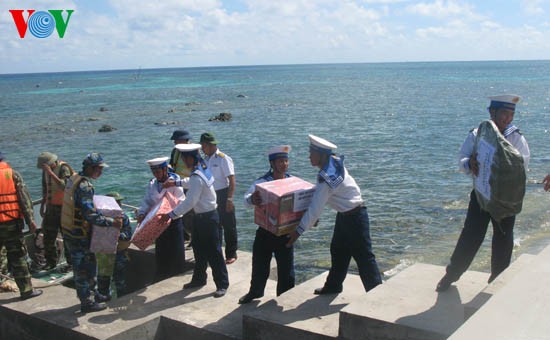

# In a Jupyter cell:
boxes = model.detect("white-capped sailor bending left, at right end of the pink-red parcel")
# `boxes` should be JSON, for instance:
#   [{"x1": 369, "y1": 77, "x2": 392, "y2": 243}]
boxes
[{"x1": 161, "y1": 144, "x2": 229, "y2": 297}]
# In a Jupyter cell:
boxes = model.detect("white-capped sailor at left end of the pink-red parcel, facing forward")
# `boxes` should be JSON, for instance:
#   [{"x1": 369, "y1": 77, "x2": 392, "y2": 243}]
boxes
[{"x1": 137, "y1": 157, "x2": 185, "y2": 281}]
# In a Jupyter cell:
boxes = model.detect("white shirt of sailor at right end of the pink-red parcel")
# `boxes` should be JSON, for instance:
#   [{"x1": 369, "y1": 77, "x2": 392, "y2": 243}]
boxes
[{"x1": 168, "y1": 174, "x2": 217, "y2": 218}]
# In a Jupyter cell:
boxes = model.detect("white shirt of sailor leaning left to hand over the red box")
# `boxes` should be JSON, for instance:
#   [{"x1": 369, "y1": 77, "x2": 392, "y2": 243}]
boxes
[{"x1": 296, "y1": 169, "x2": 363, "y2": 235}]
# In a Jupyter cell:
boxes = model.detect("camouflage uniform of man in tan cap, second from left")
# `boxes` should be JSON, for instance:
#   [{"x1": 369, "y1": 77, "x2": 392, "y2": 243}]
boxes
[{"x1": 42, "y1": 160, "x2": 72, "y2": 267}]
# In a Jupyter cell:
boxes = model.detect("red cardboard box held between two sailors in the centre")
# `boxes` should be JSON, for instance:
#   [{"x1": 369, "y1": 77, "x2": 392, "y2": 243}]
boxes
[{"x1": 254, "y1": 177, "x2": 315, "y2": 236}]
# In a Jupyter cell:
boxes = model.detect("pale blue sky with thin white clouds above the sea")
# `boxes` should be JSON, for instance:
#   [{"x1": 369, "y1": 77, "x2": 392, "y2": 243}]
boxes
[{"x1": 0, "y1": 0, "x2": 550, "y2": 74}]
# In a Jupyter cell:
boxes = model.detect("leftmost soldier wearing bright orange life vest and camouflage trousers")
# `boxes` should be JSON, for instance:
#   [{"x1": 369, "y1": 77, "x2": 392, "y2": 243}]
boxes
[{"x1": 0, "y1": 152, "x2": 42, "y2": 300}]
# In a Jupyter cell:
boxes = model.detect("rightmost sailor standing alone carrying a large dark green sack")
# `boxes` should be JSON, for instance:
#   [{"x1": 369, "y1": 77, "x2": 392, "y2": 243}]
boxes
[{"x1": 436, "y1": 95, "x2": 531, "y2": 292}]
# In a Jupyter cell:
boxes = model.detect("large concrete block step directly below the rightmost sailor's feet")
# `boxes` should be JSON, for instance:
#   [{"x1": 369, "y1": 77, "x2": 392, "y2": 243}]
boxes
[{"x1": 339, "y1": 263, "x2": 489, "y2": 340}]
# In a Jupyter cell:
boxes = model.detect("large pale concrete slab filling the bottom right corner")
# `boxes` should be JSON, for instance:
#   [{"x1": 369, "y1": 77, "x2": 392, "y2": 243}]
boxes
[{"x1": 449, "y1": 246, "x2": 550, "y2": 340}]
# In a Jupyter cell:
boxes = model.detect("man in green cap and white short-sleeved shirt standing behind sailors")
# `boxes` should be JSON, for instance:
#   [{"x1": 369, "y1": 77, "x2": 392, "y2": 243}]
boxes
[{"x1": 200, "y1": 132, "x2": 238, "y2": 264}]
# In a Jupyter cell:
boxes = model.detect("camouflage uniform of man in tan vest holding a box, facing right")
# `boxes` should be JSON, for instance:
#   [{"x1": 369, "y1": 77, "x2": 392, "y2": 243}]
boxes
[{"x1": 63, "y1": 172, "x2": 120, "y2": 305}]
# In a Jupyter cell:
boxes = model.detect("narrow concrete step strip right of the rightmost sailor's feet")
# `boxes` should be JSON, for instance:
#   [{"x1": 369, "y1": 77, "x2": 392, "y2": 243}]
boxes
[{"x1": 464, "y1": 254, "x2": 536, "y2": 319}]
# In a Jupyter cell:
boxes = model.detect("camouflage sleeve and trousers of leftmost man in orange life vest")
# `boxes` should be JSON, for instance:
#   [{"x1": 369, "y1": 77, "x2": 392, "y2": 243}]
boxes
[{"x1": 0, "y1": 165, "x2": 35, "y2": 295}]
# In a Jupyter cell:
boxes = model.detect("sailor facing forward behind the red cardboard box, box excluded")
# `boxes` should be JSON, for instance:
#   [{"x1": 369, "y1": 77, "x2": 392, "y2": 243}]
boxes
[{"x1": 239, "y1": 145, "x2": 295, "y2": 304}]
